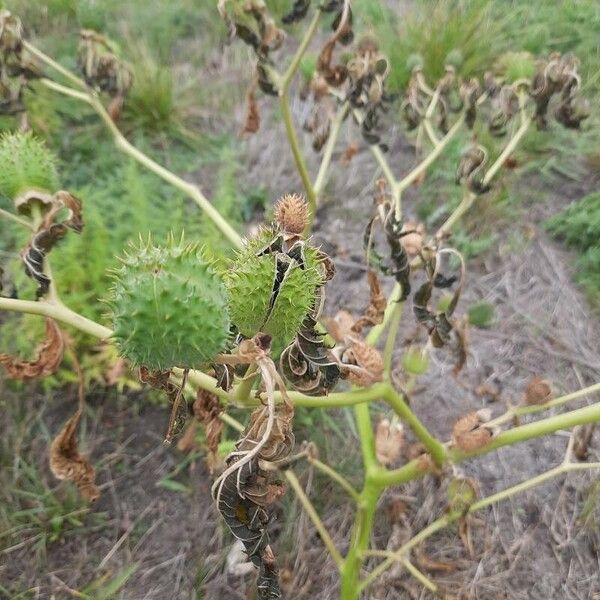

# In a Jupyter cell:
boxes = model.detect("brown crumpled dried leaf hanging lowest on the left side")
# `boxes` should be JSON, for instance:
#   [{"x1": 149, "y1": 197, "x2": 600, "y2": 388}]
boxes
[{"x1": 50, "y1": 407, "x2": 100, "y2": 502}]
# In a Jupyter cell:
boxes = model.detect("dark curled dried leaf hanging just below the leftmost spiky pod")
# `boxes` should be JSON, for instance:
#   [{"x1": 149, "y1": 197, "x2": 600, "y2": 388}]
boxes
[{"x1": 21, "y1": 191, "x2": 83, "y2": 298}]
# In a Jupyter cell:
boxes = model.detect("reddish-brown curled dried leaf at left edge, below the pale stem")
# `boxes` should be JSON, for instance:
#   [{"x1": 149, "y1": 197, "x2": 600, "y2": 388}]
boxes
[{"x1": 0, "y1": 319, "x2": 65, "y2": 379}]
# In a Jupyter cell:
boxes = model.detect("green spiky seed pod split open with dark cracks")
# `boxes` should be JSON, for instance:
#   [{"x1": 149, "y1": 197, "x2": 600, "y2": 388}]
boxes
[{"x1": 225, "y1": 229, "x2": 322, "y2": 356}]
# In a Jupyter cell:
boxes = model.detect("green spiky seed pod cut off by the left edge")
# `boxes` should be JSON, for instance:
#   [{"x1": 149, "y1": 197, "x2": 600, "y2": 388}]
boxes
[{"x1": 0, "y1": 133, "x2": 59, "y2": 200}]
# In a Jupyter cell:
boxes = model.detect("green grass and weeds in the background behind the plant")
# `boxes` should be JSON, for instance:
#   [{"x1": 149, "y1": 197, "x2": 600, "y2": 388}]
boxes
[{"x1": 0, "y1": 0, "x2": 600, "y2": 366}]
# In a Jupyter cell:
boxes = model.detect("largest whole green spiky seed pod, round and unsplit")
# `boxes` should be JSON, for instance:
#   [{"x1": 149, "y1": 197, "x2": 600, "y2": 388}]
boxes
[{"x1": 109, "y1": 239, "x2": 229, "y2": 370}]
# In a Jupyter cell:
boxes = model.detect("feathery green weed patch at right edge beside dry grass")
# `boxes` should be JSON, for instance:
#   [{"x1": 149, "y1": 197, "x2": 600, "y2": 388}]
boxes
[{"x1": 546, "y1": 192, "x2": 600, "y2": 308}]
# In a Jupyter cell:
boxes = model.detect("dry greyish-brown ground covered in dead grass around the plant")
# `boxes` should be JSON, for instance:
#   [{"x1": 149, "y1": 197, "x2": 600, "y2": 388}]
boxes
[{"x1": 0, "y1": 31, "x2": 600, "y2": 600}]
